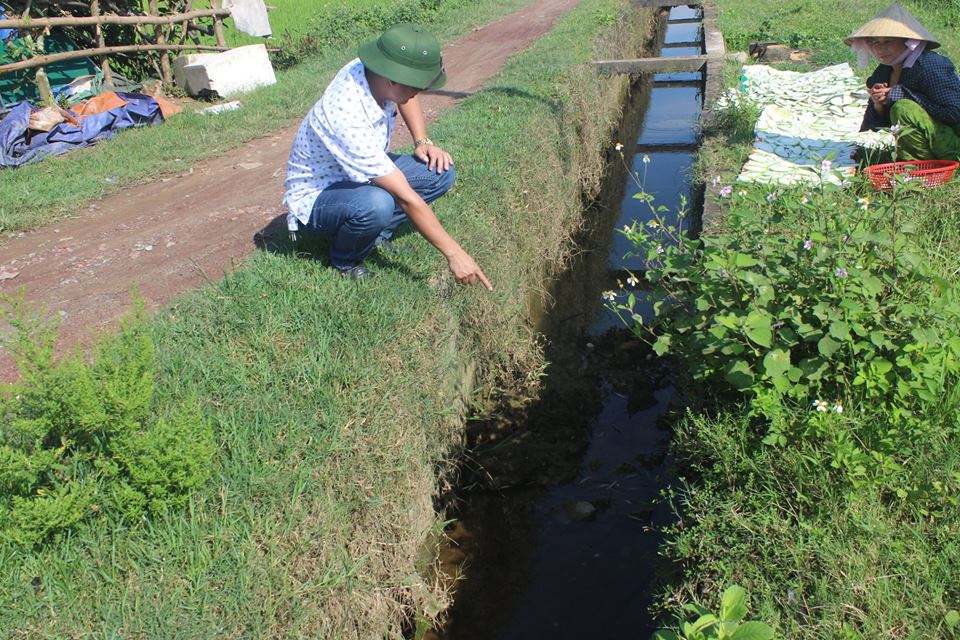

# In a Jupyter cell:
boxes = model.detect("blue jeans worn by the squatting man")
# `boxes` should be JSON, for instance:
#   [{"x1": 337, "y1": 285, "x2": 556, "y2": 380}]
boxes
[{"x1": 300, "y1": 154, "x2": 454, "y2": 269}]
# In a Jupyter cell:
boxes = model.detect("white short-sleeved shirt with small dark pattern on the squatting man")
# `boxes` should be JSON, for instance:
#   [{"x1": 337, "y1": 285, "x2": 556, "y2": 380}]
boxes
[{"x1": 283, "y1": 58, "x2": 397, "y2": 231}]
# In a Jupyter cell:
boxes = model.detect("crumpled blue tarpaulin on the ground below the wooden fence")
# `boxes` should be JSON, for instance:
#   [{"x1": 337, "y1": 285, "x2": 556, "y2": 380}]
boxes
[{"x1": 0, "y1": 93, "x2": 163, "y2": 167}]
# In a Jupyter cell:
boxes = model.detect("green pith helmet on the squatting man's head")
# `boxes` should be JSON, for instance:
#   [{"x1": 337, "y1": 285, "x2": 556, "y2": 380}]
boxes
[{"x1": 358, "y1": 24, "x2": 447, "y2": 90}]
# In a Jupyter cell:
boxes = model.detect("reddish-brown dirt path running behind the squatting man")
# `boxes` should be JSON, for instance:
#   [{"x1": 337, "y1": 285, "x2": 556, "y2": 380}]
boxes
[{"x1": 0, "y1": 0, "x2": 579, "y2": 379}]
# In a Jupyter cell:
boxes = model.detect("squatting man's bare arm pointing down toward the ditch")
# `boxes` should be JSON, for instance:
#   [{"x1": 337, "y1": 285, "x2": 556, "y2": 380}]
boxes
[{"x1": 373, "y1": 169, "x2": 493, "y2": 291}]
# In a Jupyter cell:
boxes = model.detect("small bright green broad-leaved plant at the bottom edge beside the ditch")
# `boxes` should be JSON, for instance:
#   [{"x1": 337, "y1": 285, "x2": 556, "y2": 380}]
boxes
[{"x1": 653, "y1": 585, "x2": 773, "y2": 640}]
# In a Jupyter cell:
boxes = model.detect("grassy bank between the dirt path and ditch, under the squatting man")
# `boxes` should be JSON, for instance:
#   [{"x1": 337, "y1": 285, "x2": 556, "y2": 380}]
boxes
[{"x1": 0, "y1": 0, "x2": 643, "y2": 640}]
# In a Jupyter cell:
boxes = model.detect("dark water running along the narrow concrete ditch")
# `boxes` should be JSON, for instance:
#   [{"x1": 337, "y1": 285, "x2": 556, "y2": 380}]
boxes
[{"x1": 428, "y1": 8, "x2": 703, "y2": 640}]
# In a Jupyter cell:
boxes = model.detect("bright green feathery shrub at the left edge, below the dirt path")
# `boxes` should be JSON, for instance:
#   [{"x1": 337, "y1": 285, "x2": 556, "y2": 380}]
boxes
[{"x1": 0, "y1": 296, "x2": 214, "y2": 546}]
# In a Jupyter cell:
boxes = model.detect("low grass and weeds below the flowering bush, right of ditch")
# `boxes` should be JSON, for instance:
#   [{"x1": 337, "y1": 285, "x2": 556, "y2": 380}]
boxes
[{"x1": 661, "y1": 405, "x2": 960, "y2": 640}]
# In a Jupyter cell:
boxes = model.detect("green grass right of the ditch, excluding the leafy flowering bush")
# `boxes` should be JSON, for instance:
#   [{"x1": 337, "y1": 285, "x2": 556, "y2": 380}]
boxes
[{"x1": 663, "y1": 0, "x2": 960, "y2": 640}]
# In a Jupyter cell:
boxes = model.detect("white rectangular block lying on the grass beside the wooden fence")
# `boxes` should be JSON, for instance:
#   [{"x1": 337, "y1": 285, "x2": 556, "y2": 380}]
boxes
[{"x1": 173, "y1": 44, "x2": 277, "y2": 98}]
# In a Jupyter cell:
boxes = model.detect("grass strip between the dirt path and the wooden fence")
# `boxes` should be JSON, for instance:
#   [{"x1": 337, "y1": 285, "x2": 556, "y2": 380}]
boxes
[{"x1": 0, "y1": 0, "x2": 526, "y2": 232}]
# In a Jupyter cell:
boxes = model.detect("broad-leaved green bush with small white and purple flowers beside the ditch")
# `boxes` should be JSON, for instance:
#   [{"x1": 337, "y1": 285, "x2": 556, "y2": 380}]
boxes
[{"x1": 617, "y1": 172, "x2": 960, "y2": 497}]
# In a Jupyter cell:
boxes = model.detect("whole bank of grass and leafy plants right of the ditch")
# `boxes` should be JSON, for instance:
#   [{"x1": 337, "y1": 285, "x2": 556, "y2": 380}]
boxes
[{"x1": 632, "y1": 0, "x2": 960, "y2": 639}]
